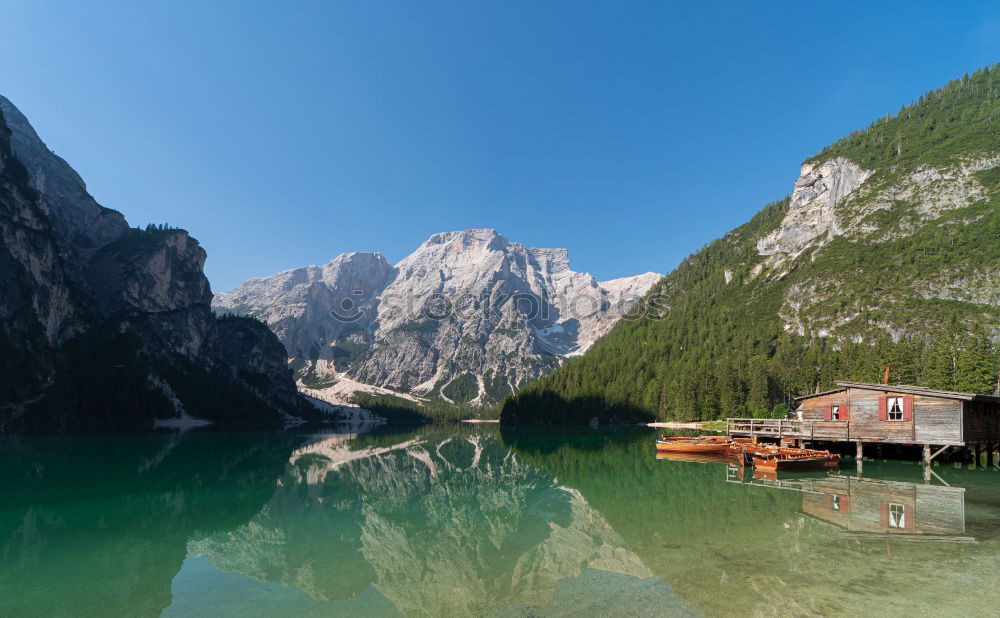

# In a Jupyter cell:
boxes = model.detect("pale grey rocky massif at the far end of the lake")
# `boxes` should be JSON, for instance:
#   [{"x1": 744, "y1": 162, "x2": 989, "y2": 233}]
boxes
[{"x1": 213, "y1": 229, "x2": 661, "y2": 405}]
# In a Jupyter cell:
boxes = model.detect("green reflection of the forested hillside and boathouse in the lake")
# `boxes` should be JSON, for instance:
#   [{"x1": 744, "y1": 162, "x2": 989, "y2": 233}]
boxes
[{"x1": 509, "y1": 432, "x2": 1000, "y2": 616}]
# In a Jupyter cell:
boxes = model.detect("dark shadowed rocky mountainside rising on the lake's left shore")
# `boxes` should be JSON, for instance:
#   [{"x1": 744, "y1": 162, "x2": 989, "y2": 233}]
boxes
[{"x1": 0, "y1": 97, "x2": 315, "y2": 433}]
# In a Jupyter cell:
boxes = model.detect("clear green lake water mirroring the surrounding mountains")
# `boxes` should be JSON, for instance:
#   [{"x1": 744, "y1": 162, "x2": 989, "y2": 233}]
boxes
[{"x1": 0, "y1": 426, "x2": 1000, "y2": 616}]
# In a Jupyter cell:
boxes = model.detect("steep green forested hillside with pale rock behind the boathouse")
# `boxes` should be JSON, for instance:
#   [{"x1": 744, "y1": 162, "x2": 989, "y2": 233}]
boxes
[{"x1": 502, "y1": 67, "x2": 1000, "y2": 423}]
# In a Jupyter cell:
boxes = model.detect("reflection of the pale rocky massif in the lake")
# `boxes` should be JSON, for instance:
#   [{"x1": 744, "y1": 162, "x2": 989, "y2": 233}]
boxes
[{"x1": 188, "y1": 427, "x2": 688, "y2": 616}]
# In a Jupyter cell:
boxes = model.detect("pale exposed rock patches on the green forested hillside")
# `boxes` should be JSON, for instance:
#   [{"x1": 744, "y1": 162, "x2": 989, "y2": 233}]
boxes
[{"x1": 745, "y1": 152, "x2": 1000, "y2": 341}]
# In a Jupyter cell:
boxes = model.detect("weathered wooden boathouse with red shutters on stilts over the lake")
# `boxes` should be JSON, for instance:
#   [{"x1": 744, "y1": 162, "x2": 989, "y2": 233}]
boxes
[{"x1": 726, "y1": 382, "x2": 1000, "y2": 463}]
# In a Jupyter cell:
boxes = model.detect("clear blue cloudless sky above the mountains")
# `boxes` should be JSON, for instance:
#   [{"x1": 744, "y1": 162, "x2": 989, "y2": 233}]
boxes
[{"x1": 0, "y1": 0, "x2": 1000, "y2": 290}]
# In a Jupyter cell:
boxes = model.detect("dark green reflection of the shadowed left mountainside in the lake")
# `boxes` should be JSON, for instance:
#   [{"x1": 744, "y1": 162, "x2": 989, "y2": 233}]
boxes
[{"x1": 0, "y1": 432, "x2": 304, "y2": 616}]
